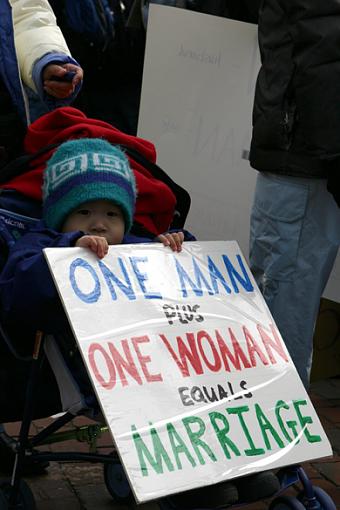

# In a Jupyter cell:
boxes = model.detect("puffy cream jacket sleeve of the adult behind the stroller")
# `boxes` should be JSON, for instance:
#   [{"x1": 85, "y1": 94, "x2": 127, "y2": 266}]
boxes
[{"x1": 10, "y1": 0, "x2": 71, "y2": 90}]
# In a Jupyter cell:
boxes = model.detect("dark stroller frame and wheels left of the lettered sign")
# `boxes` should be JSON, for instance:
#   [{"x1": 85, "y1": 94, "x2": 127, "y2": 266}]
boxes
[{"x1": 0, "y1": 325, "x2": 133, "y2": 510}]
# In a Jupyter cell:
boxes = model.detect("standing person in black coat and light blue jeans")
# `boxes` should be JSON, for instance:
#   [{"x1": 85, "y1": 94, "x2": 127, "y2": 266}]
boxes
[{"x1": 250, "y1": 0, "x2": 340, "y2": 388}]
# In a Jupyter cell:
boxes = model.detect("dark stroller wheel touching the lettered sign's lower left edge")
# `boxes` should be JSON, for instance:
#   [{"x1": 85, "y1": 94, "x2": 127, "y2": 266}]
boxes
[{"x1": 104, "y1": 460, "x2": 134, "y2": 504}]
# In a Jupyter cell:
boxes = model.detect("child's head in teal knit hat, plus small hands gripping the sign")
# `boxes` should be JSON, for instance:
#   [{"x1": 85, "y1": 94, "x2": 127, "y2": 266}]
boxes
[{"x1": 43, "y1": 139, "x2": 184, "y2": 258}]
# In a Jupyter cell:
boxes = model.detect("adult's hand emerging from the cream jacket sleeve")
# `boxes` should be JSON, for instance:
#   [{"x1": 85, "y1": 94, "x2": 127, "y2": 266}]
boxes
[{"x1": 43, "y1": 64, "x2": 84, "y2": 99}]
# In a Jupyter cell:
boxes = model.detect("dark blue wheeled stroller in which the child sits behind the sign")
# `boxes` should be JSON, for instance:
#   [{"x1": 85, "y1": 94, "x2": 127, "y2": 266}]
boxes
[{"x1": 0, "y1": 145, "x2": 335, "y2": 510}]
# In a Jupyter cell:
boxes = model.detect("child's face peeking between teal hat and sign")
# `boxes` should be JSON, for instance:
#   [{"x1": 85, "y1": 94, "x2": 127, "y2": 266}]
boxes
[{"x1": 61, "y1": 200, "x2": 125, "y2": 244}]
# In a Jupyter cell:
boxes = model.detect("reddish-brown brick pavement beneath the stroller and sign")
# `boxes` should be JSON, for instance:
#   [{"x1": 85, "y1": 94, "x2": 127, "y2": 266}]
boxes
[{"x1": 1, "y1": 378, "x2": 340, "y2": 510}]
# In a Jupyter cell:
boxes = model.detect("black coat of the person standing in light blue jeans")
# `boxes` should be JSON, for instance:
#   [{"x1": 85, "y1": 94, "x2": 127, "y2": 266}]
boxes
[{"x1": 250, "y1": 0, "x2": 340, "y2": 191}]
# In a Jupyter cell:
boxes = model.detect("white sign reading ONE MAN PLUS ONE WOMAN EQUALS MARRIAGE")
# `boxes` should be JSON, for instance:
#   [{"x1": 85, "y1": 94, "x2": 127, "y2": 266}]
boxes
[{"x1": 44, "y1": 241, "x2": 331, "y2": 502}]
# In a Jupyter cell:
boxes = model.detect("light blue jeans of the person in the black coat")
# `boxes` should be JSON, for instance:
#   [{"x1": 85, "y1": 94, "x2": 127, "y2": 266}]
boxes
[{"x1": 249, "y1": 173, "x2": 340, "y2": 388}]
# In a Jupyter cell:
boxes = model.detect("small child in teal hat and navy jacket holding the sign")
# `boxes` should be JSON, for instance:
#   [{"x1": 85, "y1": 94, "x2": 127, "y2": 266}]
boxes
[{"x1": 0, "y1": 139, "x2": 279, "y2": 508}]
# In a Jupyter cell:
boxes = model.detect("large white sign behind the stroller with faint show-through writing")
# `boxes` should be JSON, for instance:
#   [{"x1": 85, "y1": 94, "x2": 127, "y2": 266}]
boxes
[{"x1": 138, "y1": 4, "x2": 340, "y2": 301}]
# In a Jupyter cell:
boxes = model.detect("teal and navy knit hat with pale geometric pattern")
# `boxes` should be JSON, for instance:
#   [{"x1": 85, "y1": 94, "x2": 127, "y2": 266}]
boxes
[{"x1": 43, "y1": 138, "x2": 136, "y2": 232}]
